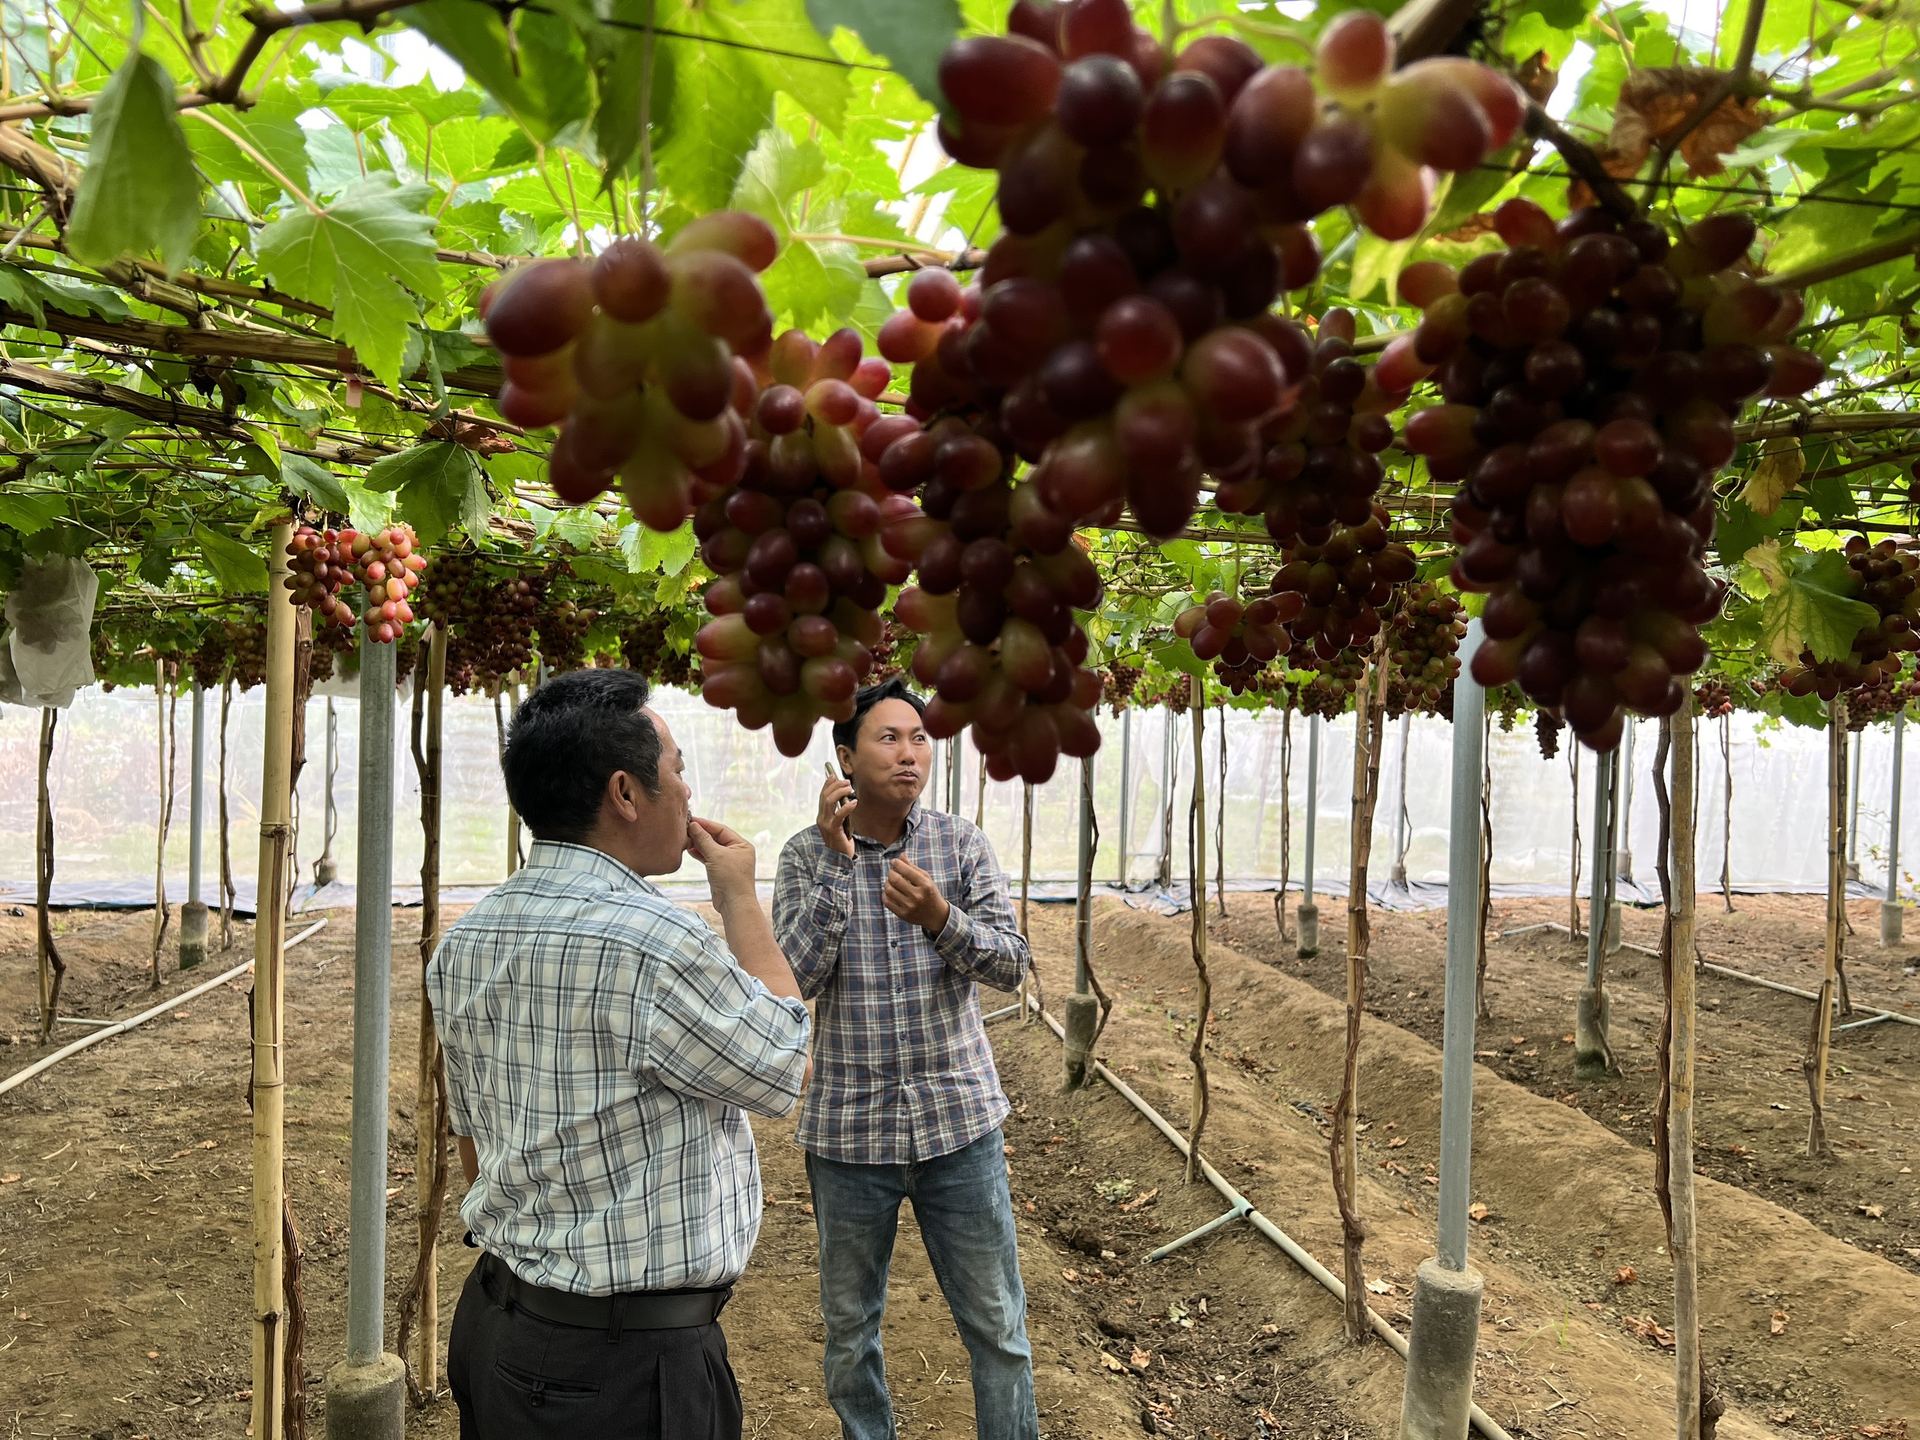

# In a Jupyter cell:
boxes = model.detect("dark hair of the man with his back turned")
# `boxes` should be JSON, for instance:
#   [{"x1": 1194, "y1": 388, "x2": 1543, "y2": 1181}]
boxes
[{"x1": 499, "y1": 670, "x2": 660, "y2": 841}]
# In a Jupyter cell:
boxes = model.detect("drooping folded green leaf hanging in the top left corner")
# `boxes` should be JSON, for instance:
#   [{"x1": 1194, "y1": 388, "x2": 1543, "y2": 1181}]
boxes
[{"x1": 67, "y1": 52, "x2": 200, "y2": 275}]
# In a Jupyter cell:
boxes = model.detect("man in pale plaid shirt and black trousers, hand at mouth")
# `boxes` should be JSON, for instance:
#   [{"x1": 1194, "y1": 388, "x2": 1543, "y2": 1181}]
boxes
[{"x1": 426, "y1": 670, "x2": 808, "y2": 1440}]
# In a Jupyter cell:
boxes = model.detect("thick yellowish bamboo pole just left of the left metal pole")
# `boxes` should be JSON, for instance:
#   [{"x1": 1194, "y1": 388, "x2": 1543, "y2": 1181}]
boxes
[{"x1": 252, "y1": 520, "x2": 296, "y2": 1440}]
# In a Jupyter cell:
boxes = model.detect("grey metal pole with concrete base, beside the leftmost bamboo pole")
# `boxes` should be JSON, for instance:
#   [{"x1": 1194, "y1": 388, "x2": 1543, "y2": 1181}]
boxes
[{"x1": 326, "y1": 634, "x2": 405, "y2": 1440}]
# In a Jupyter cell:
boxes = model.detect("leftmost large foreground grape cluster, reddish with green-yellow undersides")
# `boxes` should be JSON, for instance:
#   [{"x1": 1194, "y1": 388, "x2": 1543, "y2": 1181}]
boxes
[{"x1": 480, "y1": 211, "x2": 780, "y2": 530}]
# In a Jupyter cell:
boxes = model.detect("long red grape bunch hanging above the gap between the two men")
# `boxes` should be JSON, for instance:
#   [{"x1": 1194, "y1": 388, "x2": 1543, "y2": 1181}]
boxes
[{"x1": 693, "y1": 330, "x2": 920, "y2": 755}]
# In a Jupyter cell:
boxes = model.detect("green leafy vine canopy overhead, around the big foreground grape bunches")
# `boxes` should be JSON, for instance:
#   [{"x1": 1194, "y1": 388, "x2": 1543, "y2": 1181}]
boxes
[{"x1": 0, "y1": 0, "x2": 1920, "y2": 744}]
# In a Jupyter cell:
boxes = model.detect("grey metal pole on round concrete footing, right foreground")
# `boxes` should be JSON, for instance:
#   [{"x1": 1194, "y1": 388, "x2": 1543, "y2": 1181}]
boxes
[{"x1": 1400, "y1": 620, "x2": 1486, "y2": 1440}]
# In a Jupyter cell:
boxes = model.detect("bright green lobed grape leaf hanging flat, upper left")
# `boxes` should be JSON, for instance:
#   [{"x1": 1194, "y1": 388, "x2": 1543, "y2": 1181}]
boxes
[{"x1": 255, "y1": 175, "x2": 440, "y2": 384}]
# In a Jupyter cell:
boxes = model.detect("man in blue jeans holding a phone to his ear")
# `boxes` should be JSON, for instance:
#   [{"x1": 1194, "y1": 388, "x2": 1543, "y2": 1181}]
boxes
[{"x1": 774, "y1": 680, "x2": 1039, "y2": 1440}]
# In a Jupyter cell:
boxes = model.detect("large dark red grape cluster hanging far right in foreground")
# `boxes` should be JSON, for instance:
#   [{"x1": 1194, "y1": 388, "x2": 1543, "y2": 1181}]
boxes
[{"x1": 1405, "y1": 200, "x2": 1820, "y2": 751}]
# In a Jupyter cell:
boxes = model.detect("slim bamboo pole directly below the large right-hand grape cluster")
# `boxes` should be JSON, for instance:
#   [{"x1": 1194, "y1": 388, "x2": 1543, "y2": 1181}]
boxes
[{"x1": 1667, "y1": 691, "x2": 1701, "y2": 1440}]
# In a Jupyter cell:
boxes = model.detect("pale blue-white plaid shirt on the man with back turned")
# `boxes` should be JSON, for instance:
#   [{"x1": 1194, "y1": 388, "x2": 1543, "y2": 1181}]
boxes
[{"x1": 426, "y1": 841, "x2": 808, "y2": 1294}]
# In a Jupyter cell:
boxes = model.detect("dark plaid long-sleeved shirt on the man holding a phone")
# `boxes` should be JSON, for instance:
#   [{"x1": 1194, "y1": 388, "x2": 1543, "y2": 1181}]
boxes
[{"x1": 774, "y1": 804, "x2": 1027, "y2": 1165}]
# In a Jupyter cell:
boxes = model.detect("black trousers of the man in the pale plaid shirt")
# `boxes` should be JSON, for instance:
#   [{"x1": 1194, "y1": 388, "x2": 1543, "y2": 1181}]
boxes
[{"x1": 447, "y1": 1267, "x2": 741, "y2": 1440}]
